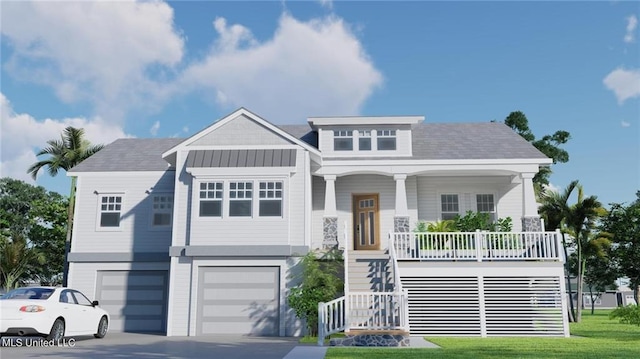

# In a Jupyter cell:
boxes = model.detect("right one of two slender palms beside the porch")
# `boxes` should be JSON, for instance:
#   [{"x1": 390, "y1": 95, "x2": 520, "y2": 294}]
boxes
[{"x1": 565, "y1": 185, "x2": 607, "y2": 322}]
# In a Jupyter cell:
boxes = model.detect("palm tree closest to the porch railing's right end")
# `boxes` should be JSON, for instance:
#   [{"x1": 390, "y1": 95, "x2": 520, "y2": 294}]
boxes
[{"x1": 540, "y1": 180, "x2": 578, "y2": 322}]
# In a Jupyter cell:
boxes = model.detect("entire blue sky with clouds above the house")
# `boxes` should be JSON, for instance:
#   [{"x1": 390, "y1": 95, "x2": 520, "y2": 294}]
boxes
[{"x1": 0, "y1": 1, "x2": 640, "y2": 207}]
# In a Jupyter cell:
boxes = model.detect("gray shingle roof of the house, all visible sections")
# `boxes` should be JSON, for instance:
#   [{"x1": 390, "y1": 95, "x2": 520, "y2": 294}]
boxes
[{"x1": 71, "y1": 122, "x2": 547, "y2": 172}]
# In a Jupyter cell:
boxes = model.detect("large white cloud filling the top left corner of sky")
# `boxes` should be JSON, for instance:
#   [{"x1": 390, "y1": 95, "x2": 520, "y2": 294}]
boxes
[{"x1": 1, "y1": 0, "x2": 184, "y2": 120}]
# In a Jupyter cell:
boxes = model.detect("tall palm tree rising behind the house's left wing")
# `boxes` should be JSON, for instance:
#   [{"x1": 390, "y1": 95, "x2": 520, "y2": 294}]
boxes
[{"x1": 27, "y1": 126, "x2": 104, "y2": 286}]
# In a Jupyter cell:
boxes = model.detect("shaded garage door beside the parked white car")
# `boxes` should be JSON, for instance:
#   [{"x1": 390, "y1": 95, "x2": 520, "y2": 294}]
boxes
[{"x1": 96, "y1": 271, "x2": 167, "y2": 332}]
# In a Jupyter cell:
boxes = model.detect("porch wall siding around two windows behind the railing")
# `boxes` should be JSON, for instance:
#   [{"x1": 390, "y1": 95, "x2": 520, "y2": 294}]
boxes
[{"x1": 418, "y1": 176, "x2": 522, "y2": 231}]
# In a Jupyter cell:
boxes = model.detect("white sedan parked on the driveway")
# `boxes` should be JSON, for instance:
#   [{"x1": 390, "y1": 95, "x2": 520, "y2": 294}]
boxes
[{"x1": 0, "y1": 287, "x2": 109, "y2": 340}]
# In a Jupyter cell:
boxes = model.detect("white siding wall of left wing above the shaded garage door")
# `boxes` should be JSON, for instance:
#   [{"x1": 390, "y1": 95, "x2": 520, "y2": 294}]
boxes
[{"x1": 71, "y1": 171, "x2": 174, "y2": 253}]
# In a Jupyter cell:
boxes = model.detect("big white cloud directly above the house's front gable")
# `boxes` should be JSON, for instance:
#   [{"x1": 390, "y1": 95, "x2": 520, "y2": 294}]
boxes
[{"x1": 177, "y1": 13, "x2": 383, "y2": 123}]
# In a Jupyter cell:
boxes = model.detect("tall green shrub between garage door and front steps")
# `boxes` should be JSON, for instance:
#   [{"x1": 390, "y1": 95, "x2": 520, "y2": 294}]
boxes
[{"x1": 287, "y1": 252, "x2": 344, "y2": 335}]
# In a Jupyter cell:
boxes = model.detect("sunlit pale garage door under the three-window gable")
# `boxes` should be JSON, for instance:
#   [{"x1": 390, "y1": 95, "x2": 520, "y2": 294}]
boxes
[{"x1": 196, "y1": 267, "x2": 280, "y2": 336}]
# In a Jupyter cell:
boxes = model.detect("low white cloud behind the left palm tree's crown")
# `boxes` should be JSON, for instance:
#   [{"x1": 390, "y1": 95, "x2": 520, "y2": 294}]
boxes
[{"x1": 0, "y1": 93, "x2": 129, "y2": 183}]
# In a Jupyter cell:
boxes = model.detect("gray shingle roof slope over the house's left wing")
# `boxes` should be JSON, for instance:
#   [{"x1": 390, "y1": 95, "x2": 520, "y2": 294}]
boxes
[{"x1": 69, "y1": 138, "x2": 184, "y2": 174}]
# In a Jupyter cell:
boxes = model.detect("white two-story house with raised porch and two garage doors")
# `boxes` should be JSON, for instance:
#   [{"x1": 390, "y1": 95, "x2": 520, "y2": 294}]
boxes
[{"x1": 68, "y1": 109, "x2": 568, "y2": 336}]
